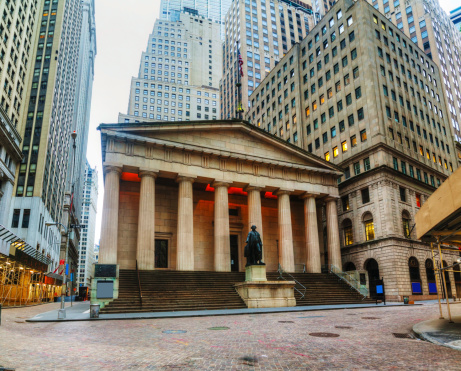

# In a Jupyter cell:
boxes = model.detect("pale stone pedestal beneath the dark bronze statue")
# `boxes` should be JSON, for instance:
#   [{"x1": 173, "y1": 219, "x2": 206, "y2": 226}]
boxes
[{"x1": 235, "y1": 265, "x2": 296, "y2": 308}]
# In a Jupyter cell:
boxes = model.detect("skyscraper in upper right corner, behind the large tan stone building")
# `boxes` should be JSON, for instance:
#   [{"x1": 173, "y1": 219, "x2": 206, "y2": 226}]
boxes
[{"x1": 369, "y1": 0, "x2": 461, "y2": 148}]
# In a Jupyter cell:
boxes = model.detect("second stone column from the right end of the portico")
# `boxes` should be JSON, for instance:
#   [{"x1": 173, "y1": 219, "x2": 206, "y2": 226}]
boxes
[{"x1": 303, "y1": 194, "x2": 322, "y2": 273}]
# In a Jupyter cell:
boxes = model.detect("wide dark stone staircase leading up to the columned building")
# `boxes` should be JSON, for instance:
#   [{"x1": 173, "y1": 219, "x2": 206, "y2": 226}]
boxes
[{"x1": 101, "y1": 270, "x2": 374, "y2": 313}]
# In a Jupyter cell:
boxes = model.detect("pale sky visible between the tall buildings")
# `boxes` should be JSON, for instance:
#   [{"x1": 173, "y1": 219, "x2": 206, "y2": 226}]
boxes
[{"x1": 87, "y1": 0, "x2": 461, "y2": 243}]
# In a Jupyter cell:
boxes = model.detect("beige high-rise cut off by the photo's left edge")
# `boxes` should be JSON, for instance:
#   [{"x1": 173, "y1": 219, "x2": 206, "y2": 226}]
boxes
[{"x1": 0, "y1": 0, "x2": 39, "y2": 227}]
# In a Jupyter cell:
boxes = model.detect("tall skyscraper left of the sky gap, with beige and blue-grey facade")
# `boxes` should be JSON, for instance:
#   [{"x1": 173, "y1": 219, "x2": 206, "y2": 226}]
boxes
[{"x1": 12, "y1": 0, "x2": 95, "y2": 270}]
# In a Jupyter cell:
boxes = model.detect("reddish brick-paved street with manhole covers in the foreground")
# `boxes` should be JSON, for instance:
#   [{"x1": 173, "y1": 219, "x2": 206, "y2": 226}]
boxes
[{"x1": 0, "y1": 303, "x2": 461, "y2": 370}]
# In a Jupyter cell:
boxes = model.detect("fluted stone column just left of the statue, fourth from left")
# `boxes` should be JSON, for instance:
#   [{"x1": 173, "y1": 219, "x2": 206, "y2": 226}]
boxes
[{"x1": 212, "y1": 181, "x2": 231, "y2": 272}]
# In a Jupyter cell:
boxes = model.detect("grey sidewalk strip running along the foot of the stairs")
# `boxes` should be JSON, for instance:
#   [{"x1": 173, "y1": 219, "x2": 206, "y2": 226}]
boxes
[{"x1": 27, "y1": 301, "x2": 403, "y2": 322}]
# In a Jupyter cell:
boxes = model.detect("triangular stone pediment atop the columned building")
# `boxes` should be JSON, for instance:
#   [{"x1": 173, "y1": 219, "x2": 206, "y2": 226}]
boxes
[{"x1": 100, "y1": 120, "x2": 341, "y2": 176}]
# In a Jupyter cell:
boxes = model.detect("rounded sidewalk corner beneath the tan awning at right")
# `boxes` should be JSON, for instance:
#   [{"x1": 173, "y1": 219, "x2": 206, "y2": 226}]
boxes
[{"x1": 413, "y1": 302, "x2": 461, "y2": 350}]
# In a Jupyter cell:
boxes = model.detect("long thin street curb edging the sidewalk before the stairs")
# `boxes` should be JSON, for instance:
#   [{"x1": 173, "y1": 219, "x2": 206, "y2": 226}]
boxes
[{"x1": 26, "y1": 304, "x2": 414, "y2": 323}]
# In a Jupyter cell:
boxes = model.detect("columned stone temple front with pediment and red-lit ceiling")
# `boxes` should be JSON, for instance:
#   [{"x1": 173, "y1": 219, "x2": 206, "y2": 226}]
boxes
[{"x1": 99, "y1": 121, "x2": 341, "y2": 273}]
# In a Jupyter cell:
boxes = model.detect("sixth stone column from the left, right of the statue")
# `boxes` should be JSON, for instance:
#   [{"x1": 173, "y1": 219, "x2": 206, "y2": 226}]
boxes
[{"x1": 276, "y1": 190, "x2": 295, "y2": 272}]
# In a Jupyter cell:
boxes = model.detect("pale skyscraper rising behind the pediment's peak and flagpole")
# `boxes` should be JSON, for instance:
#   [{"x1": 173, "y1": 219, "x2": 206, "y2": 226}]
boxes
[{"x1": 220, "y1": 0, "x2": 315, "y2": 119}]
